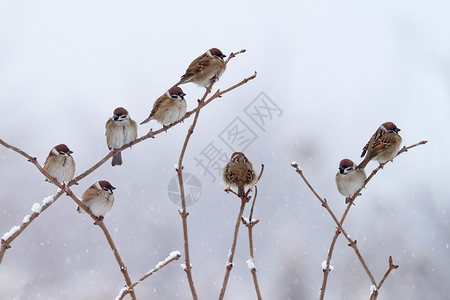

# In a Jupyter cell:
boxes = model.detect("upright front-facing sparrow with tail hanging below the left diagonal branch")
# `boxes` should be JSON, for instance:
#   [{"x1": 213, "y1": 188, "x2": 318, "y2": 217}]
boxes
[{"x1": 105, "y1": 107, "x2": 137, "y2": 166}]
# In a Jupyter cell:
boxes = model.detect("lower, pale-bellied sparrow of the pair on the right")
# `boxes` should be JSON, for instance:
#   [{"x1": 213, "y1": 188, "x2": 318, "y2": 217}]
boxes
[{"x1": 336, "y1": 159, "x2": 367, "y2": 204}]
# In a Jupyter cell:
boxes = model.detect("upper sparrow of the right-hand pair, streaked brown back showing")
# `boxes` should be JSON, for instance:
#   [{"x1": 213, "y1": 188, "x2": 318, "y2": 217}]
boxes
[{"x1": 358, "y1": 122, "x2": 402, "y2": 169}]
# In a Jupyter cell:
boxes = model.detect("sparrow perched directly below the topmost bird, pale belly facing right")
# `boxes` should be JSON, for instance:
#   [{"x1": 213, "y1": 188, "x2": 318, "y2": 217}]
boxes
[{"x1": 141, "y1": 86, "x2": 186, "y2": 126}]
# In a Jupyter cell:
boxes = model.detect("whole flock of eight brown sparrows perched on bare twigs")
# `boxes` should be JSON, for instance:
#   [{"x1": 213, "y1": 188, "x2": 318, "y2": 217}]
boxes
[{"x1": 40, "y1": 48, "x2": 402, "y2": 218}]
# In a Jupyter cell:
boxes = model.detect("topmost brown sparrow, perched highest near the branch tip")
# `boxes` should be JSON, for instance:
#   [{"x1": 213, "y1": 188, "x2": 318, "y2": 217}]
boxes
[{"x1": 176, "y1": 48, "x2": 226, "y2": 87}]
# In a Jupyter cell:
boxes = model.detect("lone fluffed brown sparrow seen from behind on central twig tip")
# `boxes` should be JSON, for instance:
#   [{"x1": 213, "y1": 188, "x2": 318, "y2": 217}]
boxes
[{"x1": 222, "y1": 152, "x2": 258, "y2": 197}]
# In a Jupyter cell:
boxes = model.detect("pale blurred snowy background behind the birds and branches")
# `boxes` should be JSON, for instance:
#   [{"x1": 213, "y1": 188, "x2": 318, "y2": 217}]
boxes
[{"x1": 0, "y1": 0, "x2": 450, "y2": 300}]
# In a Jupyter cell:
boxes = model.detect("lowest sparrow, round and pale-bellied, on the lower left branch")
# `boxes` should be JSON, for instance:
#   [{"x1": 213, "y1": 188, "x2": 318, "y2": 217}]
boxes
[{"x1": 77, "y1": 180, "x2": 116, "y2": 218}]
